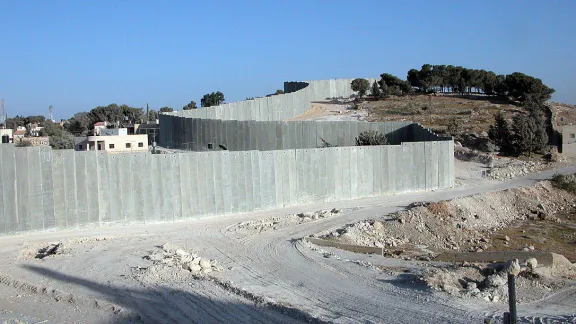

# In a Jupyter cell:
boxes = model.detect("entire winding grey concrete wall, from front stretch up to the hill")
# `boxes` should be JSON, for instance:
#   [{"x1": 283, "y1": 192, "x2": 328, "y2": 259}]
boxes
[{"x1": 0, "y1": 79, "x2": 454, "y2": 235}]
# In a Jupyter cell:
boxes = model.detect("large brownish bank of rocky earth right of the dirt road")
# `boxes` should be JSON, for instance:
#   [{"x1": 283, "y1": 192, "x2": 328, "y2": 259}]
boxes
[{"x1": 315, "y1": 181, "x2": 576, "y2": 257}]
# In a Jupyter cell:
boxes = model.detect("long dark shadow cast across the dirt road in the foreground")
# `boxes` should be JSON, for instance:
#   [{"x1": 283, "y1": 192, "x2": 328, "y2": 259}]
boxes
[{"x1": 22, "y1": 265, "x2": 325, "y2": 324}]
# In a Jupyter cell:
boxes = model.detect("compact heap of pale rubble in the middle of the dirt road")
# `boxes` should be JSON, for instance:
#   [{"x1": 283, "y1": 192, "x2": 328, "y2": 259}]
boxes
[{"x1": 144, "y1": 243, "x2": 224, "y2": 274}]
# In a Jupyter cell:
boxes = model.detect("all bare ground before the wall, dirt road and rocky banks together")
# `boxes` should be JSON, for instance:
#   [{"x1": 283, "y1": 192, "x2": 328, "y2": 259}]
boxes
[{"x1": 0, "y1": 163, "x2": 576, "y2": 323}]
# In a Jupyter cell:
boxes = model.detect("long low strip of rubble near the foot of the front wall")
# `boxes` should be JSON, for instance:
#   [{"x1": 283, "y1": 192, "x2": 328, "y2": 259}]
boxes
[{"x1": 231, "y1": 208, "x2": 341, "y2": 233}]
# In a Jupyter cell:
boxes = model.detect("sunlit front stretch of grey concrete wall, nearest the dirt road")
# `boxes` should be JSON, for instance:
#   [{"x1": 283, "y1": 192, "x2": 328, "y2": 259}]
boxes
[{"x1": 0, "y1": 141, "x2": 454, "y2": 235}]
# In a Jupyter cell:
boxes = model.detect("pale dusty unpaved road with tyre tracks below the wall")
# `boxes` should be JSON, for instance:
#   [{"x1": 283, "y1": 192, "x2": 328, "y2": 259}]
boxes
[{"x1": 0, "y1": 166, "x2": 576, "y2": 323}]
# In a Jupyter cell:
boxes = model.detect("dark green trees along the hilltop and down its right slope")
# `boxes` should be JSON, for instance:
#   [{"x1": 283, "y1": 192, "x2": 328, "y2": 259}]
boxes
[{"x1": 351, "y1": 64, "x2": 554, "y2": 154}]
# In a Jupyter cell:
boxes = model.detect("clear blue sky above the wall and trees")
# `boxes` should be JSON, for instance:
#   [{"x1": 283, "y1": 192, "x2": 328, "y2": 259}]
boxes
[{"x1": 0, "y1": 0, "x2": 576, "y2": 119}]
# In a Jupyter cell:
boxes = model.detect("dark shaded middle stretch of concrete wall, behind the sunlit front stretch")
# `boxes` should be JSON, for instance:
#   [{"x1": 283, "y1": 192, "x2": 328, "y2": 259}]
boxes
[{"x1": 160, "y1": 115, "x2": 451, "y2": 151}]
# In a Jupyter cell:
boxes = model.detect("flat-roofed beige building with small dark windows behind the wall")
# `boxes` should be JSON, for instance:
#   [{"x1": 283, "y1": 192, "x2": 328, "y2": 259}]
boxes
[{"x1": 74, "y1": 135, "x2": 148, "y2": 153}]
